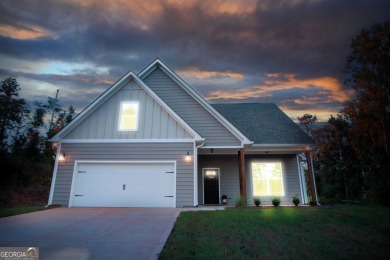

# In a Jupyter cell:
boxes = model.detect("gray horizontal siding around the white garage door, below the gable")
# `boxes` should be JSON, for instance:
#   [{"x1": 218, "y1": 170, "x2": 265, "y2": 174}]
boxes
[{"x1": 52, "y1": 142, "x2": 194, "y2": 208}]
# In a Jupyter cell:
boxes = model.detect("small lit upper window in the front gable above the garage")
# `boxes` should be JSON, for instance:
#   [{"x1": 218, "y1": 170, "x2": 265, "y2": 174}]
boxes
[{"x1": 119, "y1": 101, "x2": 139, "y2": 131}]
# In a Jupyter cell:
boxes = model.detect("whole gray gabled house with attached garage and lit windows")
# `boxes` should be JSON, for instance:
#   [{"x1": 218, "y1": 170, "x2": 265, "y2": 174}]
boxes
[{"x1": 49, "y1": 59, "x2": 313, "y2": 208}]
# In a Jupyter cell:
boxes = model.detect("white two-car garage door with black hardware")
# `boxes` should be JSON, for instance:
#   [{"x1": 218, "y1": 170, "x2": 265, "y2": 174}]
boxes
[{"x1": 70, "y1": 162, "x2": 175, "y2": 208}]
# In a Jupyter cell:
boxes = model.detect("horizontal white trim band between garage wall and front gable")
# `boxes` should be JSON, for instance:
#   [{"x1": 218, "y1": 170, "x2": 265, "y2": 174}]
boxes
[{"x1": 60, "y1": 138, "x2": 198, "y2": 144}]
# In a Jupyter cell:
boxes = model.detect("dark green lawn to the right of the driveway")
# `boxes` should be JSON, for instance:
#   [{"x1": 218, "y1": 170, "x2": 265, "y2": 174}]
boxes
[{"x1": 159, "y1": 205, "x2": 390, "y2": 259}]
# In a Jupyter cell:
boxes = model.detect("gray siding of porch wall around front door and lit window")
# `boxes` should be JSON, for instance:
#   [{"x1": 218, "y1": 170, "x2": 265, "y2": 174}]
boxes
[{"x1": 198, "y1": 154, "x2": 301, "y2": 205}]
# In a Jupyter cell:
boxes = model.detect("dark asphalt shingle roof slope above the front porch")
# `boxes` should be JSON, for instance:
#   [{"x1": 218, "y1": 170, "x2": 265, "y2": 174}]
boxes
[{"x1": 212, "y1": 103, "x2": 314, "y2": 145}]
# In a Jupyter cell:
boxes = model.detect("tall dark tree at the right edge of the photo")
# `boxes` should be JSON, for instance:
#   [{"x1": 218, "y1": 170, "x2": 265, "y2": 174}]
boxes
[{"x1": 341, "y1": 21, "x2": 390, "y2": 203}]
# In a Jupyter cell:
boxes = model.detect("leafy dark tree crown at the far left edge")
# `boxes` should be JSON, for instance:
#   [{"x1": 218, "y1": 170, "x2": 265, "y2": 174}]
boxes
[{"x1": 0, "y1": 77, "x2": 29, "y2": 152}]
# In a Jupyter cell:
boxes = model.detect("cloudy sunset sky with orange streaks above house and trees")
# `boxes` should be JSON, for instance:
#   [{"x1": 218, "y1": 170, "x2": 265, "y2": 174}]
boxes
[{"x1": 0, "y1": 0, "x2": 390, "y2": 120}]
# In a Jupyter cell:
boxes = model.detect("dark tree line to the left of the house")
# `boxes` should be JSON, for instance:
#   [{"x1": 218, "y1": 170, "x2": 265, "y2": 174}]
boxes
[{"x1": 0, "y1": 77, "x2": 75, "y2": 206}]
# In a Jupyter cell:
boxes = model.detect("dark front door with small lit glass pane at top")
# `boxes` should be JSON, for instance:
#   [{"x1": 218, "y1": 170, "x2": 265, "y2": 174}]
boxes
[{"x1": 203, "y1": 169, "x2": 219, "y2": 204}]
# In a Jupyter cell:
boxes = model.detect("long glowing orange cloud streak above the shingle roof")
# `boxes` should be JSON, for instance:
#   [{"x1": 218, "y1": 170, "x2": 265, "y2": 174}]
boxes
[{"x1": 206, "y1": 74, "x2": 351, "y2": 104}]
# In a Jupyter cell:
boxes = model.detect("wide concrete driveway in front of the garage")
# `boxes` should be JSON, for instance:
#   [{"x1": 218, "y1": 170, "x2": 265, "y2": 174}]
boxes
[{"x1": 0, "y1": 208, "x2": 180, "y2": 259}]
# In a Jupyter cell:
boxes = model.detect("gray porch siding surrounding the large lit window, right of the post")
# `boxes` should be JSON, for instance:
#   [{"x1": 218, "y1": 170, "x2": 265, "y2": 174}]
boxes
[{"x1": 245, "y1": 154, "x2": 301, "y2": 205}]
